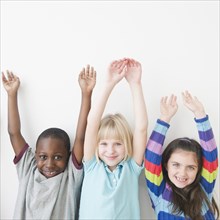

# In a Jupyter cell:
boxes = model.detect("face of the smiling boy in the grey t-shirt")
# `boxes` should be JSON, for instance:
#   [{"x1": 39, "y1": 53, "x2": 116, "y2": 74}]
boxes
[{"x1": 35, "y1": 137, "x2": 69, "y2": 178}]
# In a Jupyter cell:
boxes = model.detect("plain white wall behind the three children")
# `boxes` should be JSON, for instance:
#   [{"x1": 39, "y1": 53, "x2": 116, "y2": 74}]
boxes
[{"x1": 0, "y1": 1, "x2": 219, "y2": 219}]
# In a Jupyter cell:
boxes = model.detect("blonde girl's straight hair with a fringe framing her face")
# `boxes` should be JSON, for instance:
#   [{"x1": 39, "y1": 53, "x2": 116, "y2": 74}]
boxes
[{"x1": 96, "y1": 113, "x2": 133, "y2": 161}]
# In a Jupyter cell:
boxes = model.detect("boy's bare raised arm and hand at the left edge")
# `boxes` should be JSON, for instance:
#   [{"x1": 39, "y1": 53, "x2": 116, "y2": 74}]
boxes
[{"x1": 2, "y1": 71, "x2": 26, "y2": 156}]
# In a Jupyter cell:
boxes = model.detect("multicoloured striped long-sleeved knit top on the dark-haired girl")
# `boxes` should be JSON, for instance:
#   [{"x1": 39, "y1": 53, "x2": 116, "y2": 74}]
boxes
[{"x1": 145, "y1": 116, "x2": 218, "y2": 220}]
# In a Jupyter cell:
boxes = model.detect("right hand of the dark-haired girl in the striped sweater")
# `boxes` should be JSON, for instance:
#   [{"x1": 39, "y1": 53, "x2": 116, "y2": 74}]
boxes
[{"x1": 182, "y1": 91, "x2": 206, "y2": 119}]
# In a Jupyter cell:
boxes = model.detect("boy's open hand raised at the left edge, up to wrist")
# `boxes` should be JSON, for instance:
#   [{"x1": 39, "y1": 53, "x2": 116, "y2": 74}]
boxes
[{"x1": 2, "y1": 70, "x2": 20, "y2": 95}]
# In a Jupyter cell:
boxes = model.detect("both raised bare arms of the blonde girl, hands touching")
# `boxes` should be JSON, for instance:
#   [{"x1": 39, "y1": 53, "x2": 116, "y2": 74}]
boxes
[{"x1": 84, "y1": 59, "x2": 148, "y2": 168}]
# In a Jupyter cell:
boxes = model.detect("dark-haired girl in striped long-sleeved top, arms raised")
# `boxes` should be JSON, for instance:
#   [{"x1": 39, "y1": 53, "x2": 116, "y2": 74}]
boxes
[{"x1": 145, "y1": 91, "x2": 219, "y2": 220}]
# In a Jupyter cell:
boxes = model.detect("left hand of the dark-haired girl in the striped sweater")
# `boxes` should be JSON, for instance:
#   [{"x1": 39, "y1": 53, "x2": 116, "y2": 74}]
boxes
[{"x1": 160, "y1": 94, "x2": 178, "y2": 123}]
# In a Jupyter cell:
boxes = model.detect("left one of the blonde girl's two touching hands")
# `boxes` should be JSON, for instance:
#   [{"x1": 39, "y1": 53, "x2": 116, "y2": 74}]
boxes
[{"x1": 107, "y1": 59, "x2": 127, "y2": 84}]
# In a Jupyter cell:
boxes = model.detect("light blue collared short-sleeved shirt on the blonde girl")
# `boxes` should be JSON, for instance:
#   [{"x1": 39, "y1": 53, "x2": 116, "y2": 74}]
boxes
[{"x1": 79, "y1": 157, "x2": 143, "y2": 220}]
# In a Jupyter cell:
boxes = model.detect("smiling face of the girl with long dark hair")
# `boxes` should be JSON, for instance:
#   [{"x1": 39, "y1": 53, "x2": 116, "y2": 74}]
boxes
[{"x1": 167, "y1": 150, "x2": 198, "y2": 188}]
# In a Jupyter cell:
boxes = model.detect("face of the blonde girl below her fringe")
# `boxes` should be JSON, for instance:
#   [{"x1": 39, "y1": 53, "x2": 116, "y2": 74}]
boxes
[{"x1": 98, "y1": 139, "x2": 125, "y2": 171}]
